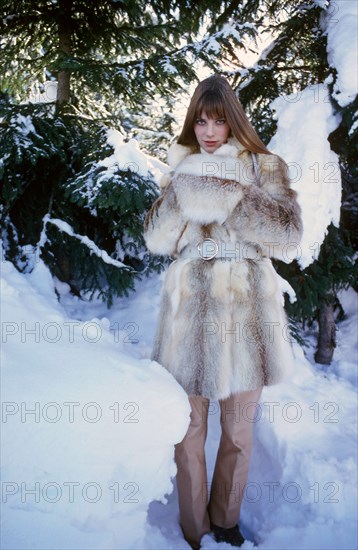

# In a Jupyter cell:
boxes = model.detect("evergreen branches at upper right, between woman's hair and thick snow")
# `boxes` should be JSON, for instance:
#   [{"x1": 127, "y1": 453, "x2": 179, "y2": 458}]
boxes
[{"x1": 225, "y1": 0, "x2": 330, "y2": 143}]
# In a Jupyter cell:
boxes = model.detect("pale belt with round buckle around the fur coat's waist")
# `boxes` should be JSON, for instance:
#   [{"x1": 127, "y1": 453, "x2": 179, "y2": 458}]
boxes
[{"x1": 178, "y1": 238, "x2": 263, "y2": 261}]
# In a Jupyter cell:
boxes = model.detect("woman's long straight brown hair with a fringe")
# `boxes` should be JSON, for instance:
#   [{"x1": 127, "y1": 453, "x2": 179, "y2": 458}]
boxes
[{"x1": 178, "y1": 75, "x2": 271, "y2": 154}]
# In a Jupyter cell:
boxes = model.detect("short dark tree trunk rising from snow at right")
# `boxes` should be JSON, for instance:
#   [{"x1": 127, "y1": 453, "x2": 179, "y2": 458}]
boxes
[{"x1": 314, "y1": 304, "x2": 336, "y2": 365}]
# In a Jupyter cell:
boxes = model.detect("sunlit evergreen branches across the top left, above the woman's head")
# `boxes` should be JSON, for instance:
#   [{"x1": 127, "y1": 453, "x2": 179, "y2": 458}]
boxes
[{"x1": 0, "y1": 0, "x2": 255, "y2": 108}]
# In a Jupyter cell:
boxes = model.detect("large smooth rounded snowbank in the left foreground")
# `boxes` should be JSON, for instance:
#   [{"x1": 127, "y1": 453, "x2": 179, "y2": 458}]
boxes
[{"x1": 1, "y1": 261, "x2": 190, "y2": 549}]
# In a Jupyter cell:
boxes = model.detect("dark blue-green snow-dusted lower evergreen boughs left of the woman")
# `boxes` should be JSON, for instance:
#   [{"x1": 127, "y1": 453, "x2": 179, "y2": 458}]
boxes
[{"x1": 0, "y1": 99, "x2": 160, "y2": 304}]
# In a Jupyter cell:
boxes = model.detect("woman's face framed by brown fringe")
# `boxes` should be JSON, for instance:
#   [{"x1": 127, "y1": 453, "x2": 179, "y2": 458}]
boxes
[{"x1": 194, "y1": 111, "x2": 230, "y2": 153}]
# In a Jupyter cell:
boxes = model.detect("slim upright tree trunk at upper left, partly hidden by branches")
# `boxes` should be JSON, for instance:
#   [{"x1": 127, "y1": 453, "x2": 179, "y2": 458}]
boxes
[{"x1": 56, "y1": 2, "x2": 72, "y2": 105}]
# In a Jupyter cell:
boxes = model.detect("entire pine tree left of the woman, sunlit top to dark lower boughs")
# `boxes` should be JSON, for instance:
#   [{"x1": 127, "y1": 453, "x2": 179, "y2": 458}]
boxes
[{"x1": 0, "y1": 0, "x2": 255, "y2": 304}]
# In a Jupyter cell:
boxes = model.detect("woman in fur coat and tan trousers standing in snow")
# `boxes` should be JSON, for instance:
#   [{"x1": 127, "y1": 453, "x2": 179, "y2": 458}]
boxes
[{"x1": 144, "y1": 76, "x2": 301, "y2": 548}]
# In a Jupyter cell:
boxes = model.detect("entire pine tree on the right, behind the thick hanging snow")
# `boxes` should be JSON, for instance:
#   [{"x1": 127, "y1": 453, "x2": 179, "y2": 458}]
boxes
[{"x1": 226, "y1": 0, "x2": 358, "y2": 364}]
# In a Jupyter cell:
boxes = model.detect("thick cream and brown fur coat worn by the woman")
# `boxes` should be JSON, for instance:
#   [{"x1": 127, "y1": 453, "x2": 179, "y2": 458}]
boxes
[{"x1": 144, "y1": 138, "x2": 301, "y2": 399}]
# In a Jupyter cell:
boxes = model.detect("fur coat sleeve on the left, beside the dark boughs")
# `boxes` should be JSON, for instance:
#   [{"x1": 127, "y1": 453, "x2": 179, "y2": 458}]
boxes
[{"x1": 143, "y1": 184, "x2": 186, "y2": 255}]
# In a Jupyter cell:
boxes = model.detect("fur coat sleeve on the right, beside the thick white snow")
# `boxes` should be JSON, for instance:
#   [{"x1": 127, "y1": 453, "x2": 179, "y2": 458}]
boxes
[{"x1": 229, "y1": 155, "x2": 302, "y2": 262}]
